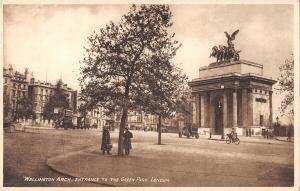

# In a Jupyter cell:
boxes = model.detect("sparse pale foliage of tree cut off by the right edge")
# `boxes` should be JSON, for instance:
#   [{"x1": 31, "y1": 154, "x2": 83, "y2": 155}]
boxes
[{"x1": 277, "y1": 55, "x2": 294, "y2": 116}]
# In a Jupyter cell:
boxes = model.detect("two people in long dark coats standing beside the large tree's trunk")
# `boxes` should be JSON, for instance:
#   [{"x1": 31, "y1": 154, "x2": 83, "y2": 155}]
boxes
[{"x1": 101, "y1": 126, "x2": 133, "y2": 155}]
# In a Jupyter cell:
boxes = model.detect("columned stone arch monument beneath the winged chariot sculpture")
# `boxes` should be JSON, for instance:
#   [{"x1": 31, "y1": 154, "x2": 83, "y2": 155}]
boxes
[{"x1": 189, "y1": 60, "x2": 276, "y2": 137}]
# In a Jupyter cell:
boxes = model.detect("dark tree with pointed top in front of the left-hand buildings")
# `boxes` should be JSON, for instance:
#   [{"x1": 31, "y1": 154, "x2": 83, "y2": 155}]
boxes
[{"x1": 43, "y1": 79, "x2": 69, "y2": 124}]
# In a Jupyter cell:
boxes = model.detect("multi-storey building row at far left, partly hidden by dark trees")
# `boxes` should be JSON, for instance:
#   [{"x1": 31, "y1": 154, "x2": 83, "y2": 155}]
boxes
[{"x1": 3, "y1": 66, "x2": 77, "y2": 123}]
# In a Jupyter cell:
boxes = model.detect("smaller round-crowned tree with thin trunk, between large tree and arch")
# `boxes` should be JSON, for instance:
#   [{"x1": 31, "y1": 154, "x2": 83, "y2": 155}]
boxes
[{"x1": 139, "y1": 67, "x2": 189, "y2": 145}]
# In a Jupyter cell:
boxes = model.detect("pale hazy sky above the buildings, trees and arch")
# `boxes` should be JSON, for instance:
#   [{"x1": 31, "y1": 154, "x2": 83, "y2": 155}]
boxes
[{"x1": 3, "y1": 4, "x2": 294, "y2": 124}]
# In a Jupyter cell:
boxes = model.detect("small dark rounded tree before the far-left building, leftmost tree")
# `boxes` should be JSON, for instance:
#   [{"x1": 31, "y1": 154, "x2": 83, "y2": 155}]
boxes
[{"x1": 15, "y1": 97, "x2": 35, "y2": 119}]
